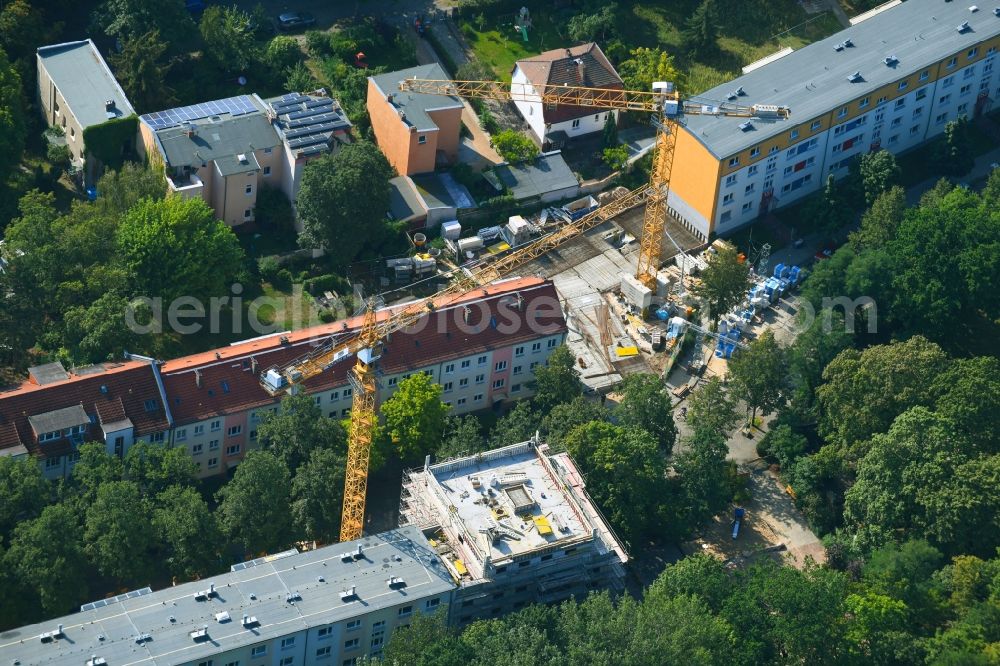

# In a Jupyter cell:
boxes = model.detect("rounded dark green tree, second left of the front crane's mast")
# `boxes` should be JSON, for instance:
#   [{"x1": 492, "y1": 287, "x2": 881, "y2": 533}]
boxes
[{"x1": 216, "y1": 450, "x2": 292, "y2": 553}]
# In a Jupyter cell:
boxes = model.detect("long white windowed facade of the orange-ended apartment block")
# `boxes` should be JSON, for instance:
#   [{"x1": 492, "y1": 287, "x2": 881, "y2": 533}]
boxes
[{"x1": 716, "y1": 48, "x2": 1000, "y2": 235}]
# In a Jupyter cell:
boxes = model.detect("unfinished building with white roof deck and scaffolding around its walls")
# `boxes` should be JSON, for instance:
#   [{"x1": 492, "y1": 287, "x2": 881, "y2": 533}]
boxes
[{"x1": 400, "y1": 440, "x2": 628, "y2": 626}]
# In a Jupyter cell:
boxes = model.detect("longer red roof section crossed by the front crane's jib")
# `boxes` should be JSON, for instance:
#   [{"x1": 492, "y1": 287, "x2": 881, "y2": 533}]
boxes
[{"x1": 162, "y1": 278, "x2": 566, "y2": 425}]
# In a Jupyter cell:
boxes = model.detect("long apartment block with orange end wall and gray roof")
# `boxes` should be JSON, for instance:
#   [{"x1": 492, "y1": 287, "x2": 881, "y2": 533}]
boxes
[{"x1": 669, "y1": 0, "x2": 1000, "y2": 238}]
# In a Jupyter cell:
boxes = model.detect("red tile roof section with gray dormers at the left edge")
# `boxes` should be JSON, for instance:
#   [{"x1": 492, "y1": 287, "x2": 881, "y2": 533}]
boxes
[{"x1": 0, "y1": 360, "x2": 169, "y2": 457}]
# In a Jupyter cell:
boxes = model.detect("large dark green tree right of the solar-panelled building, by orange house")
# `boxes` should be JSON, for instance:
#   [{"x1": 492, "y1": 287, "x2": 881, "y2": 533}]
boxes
[{"x1": 297, "y1": 141, "x2": 396, "y2": 266}]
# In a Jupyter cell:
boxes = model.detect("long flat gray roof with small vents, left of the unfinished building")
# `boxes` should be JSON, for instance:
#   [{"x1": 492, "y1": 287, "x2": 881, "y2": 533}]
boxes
[{"x1": 0, "y1": 527, "x2": 455, "y2": 666}]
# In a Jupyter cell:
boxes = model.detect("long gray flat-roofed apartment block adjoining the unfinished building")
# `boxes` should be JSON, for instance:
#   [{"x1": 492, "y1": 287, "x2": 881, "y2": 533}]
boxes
[{"x1": 0, "y1": 527, "x2": 455, "y2": 666}]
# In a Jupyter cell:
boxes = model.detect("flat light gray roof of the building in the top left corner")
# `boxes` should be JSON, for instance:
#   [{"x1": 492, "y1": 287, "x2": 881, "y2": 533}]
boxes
[{"x1": 37, "y1": 39, "x2": 135, "y2": 128}]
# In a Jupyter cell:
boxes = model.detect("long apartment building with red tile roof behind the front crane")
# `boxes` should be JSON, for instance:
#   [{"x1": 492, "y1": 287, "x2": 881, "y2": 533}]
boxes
[{"x1": 0, "y1": 278, "x2": 567, "y2": 478}]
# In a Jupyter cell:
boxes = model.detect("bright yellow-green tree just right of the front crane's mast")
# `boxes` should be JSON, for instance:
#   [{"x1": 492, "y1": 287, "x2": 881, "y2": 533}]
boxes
[{"x1": 380, "y1": 372, "x2": 449, "y2": 462}]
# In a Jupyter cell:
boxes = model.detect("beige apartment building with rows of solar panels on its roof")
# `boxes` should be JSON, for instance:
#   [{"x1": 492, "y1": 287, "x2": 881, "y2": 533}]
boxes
[{"x1": 139, "y1": 91, "x2": 351, "y2": 226}]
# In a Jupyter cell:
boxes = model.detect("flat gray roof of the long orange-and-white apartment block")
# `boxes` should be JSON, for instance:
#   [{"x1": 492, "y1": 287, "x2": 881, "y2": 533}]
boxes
[{"x1": 682, "y1": 0, "x2": 1000, "y2": 159}]
